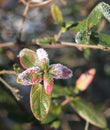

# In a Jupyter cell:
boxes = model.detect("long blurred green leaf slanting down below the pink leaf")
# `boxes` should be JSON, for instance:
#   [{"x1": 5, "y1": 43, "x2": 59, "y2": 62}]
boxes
[{"x1": 70, "y1": 98, "x2": 107, "y2": 128}]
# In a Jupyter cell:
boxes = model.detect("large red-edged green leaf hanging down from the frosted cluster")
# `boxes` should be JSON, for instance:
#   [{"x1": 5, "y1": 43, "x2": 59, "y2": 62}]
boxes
[{"x1": 30, "y1": 84, "x2": 51, "y2": 121}]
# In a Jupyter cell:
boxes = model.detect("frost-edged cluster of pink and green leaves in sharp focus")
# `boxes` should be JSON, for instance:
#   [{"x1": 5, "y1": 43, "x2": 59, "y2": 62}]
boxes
[{"x1": 17, "y1": 49, "x2": 72, "y2": 120}]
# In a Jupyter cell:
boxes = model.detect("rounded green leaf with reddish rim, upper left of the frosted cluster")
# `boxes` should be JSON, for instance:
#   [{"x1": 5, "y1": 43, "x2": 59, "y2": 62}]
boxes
[{"x1": 19, "y1": 48, "x2": 38, "y2": 69}]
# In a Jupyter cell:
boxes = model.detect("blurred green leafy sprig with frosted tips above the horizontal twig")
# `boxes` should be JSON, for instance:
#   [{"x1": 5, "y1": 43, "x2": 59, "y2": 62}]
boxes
[{"x1": 51, "y1": 2, "x2": 110, "y2": 48}]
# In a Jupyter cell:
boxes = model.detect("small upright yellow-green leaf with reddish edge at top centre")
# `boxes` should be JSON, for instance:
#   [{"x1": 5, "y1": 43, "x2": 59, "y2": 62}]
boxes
[{"x1": 51, "y1": 5, "x2": 64, "y2": 26}]
